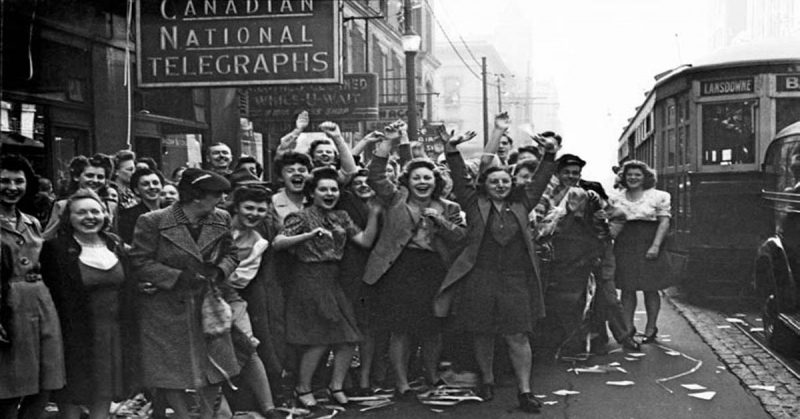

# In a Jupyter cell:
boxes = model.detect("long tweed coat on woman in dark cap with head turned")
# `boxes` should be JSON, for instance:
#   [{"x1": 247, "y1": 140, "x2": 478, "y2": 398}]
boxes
[{"x1": 130, "y1": 203, "x2": 239, "y2": 389}]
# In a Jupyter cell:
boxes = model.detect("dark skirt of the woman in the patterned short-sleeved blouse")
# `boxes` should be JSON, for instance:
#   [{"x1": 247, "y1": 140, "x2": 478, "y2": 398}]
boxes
[{"x1": 286, "y1": 262, "x2": 361, "y2": 346}]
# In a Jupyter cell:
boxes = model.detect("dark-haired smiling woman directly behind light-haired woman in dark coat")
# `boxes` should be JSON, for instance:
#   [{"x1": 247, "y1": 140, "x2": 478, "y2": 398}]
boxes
[{"x1": 42, "y1": 153, "x2": 117, "y2": 240}]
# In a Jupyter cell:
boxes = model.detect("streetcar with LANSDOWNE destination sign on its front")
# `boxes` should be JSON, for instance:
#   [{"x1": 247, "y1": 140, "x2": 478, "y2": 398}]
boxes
[{"x1": 618, "y1": 41, "x2": 800, "y2": 299}]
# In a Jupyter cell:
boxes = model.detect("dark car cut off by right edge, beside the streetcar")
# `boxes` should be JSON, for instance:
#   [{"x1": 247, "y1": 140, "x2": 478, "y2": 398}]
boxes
[{"x1": 753, "y1": 122, "x2": 800, "y2": 356}]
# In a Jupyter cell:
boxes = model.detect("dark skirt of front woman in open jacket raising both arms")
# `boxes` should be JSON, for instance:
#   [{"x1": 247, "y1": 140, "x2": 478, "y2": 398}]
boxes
[{"x1": 451, "y1": 268, "x2": 534, "y2": 335}]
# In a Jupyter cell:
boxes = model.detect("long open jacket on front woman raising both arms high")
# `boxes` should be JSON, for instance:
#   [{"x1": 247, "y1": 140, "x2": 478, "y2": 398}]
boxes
[{"x1": 434, "y1": 152, "x2": 556, "y2": 320}]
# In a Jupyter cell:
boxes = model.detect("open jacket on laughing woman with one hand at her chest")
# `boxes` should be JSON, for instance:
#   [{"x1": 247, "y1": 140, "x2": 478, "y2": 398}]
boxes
[{"x1": 363, "y1": 156, "x2": 466, "y2": 285}]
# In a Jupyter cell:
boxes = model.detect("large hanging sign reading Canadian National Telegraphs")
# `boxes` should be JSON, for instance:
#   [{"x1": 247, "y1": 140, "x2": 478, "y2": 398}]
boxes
[{"x1": 136, "y1": 0, "x2": 342, "y2": 87}]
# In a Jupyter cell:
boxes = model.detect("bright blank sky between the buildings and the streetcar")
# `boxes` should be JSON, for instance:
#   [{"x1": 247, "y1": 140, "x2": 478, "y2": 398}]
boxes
[{"x1": 432, "y1": 0, "x2": 711, "y2": 184}]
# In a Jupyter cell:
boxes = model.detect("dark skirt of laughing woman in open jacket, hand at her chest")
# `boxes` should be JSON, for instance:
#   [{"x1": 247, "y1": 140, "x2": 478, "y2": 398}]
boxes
[{"x1": 374, "y1": 248, "x2": 447, "y2": 336}]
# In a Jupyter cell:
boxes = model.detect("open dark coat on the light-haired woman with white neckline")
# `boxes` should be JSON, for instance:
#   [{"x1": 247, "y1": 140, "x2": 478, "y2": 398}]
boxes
[{"x1": 41, "y1": 234, "x2": 140, "y2": 397}]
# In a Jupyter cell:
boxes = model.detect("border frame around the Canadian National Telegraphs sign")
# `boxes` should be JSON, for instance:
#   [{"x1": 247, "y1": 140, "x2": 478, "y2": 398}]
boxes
[{"x1": 135, "y1": 0, "x2": 343, "y2": 88}]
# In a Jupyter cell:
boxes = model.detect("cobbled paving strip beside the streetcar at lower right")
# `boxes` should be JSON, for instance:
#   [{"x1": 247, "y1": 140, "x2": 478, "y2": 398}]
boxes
[{"x1": 665, "y1": 289, "x2": 800, "y2": 419}]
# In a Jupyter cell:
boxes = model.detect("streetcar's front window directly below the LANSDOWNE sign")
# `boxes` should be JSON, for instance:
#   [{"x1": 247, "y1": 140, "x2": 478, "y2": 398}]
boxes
[{"x1": 702, "y1": 100, "x2": 758, "y2": 166}]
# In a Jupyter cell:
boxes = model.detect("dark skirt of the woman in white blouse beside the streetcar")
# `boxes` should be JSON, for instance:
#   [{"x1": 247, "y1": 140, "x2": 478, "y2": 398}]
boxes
[{"x1": 614, "y1": 221, "x2": 675, "y2": 291}]
